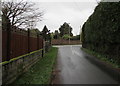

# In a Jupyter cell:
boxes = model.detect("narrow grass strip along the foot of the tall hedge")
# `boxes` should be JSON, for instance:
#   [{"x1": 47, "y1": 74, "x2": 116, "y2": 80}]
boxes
[{"x1": 82, "y1": 48, "x2": 120, "y2": 68}]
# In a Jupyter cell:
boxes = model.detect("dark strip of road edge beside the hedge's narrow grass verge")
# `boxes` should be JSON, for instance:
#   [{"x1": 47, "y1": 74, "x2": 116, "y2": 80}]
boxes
[{"x1": 81, "y1": 49, "x2": 120, "y2": 84}]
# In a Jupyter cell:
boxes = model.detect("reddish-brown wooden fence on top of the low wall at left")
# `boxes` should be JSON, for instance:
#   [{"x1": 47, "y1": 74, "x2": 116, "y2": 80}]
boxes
[{"x1": 2, "y1": 29, "x2": 43, "y2": 61}]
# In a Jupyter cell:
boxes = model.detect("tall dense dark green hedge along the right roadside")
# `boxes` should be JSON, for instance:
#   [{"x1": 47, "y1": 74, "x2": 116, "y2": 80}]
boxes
[{"x1": 82, "y1": 2, "x2": 120, "y2": 62}]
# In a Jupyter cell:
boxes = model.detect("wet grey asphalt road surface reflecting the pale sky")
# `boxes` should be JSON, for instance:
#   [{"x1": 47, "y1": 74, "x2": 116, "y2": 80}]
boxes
[{"x1": 54, "y1": 45, "x2": 118, "y2": 84}]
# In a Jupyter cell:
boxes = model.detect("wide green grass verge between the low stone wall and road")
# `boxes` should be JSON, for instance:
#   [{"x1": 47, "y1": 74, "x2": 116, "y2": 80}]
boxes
[{"x1": 13, "y1": 47, "x2": 58, "y2": 84}]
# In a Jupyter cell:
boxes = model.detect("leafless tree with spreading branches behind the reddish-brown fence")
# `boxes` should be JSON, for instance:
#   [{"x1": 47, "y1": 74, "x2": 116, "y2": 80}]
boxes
[{"x1": 2, "y1": 0, "x2": 43, "y2": 27}]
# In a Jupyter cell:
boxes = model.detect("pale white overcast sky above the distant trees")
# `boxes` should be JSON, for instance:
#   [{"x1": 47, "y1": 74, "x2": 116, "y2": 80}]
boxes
[{"x1": 36, "y1": 0, "x2": 97, "y2": 35}]
